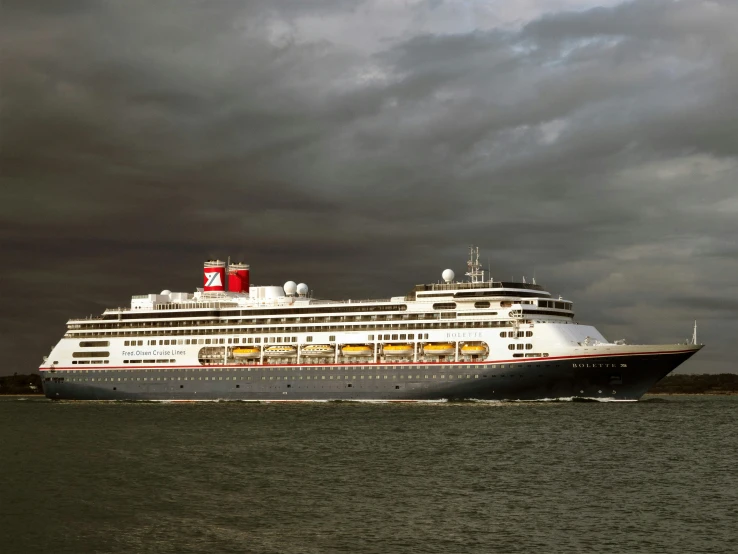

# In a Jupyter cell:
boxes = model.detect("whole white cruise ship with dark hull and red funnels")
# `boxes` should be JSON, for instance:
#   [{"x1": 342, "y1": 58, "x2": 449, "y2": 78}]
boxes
[{"x1": 39, "y1": 248, "x2": 702, "y2": 401}]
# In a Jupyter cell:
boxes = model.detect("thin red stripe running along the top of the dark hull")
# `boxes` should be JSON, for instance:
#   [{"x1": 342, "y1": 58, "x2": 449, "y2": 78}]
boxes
[{"x1": 38, "y1": 348, "x2": 696, "y2": 371}]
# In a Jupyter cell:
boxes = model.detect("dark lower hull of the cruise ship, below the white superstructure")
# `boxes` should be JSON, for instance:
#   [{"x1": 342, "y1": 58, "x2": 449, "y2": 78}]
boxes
[{"x1": 44, "y1": 348, "x2": 698, "y2": 401}]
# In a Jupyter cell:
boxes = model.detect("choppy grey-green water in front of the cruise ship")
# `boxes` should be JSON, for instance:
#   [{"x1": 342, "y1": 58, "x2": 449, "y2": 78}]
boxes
[{"x1": 0, "y1": 397, "x2": 738, "y2": 554}]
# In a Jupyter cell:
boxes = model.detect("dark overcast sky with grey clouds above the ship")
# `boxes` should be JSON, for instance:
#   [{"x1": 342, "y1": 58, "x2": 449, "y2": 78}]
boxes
[{"x1": 0, "y1": 0, "x2": 738, "y2": 374}]
